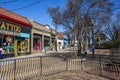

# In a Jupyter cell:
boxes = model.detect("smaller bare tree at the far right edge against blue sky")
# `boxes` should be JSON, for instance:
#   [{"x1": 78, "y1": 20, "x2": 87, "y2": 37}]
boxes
[{"x1": 103, "y1": 21, "x2": 120, "y2": 48}]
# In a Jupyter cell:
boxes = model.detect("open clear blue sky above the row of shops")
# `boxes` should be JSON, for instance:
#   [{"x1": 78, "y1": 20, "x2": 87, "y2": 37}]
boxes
[{"x1": 0, "y1": 0, "x2": 66, "y2": 29}]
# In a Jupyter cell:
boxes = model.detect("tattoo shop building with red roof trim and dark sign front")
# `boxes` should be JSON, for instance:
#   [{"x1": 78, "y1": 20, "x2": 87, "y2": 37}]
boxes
[{"x1": 0, "y1": 8, "x2": 32, "y2": 56}]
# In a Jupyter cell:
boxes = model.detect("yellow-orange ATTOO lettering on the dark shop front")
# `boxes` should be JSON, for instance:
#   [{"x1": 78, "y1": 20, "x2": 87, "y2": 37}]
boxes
[{"x1": 0, "y1": 21, "x2": 21, "y2": 32}]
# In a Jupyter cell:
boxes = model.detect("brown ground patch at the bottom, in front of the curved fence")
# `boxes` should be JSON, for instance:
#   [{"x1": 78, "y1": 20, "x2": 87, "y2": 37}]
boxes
[{"x1": 31, "y1": 71, "x2": 109, "y2": 80}]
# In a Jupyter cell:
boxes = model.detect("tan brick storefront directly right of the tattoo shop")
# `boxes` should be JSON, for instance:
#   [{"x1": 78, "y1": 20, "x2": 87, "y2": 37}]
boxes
[{"x1": 29, "y1": 20, "x2": 51, "y2": 53}]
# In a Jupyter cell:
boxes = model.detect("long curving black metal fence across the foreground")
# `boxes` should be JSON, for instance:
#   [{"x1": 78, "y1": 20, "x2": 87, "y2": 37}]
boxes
[{"x1": 0, "y1": 53, "x2": 120, "y2": 80}]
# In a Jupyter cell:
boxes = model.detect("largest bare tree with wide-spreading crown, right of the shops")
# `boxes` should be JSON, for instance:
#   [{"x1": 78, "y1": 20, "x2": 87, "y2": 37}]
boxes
[{"x1": 47, "y1": 0, "x2": 112, "y2": 55}]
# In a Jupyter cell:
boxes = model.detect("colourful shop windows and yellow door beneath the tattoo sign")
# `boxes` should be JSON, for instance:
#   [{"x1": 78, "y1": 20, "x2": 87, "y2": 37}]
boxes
[{"x1": 0, "y1": 35, "x2": 29, "y2": 54}]
